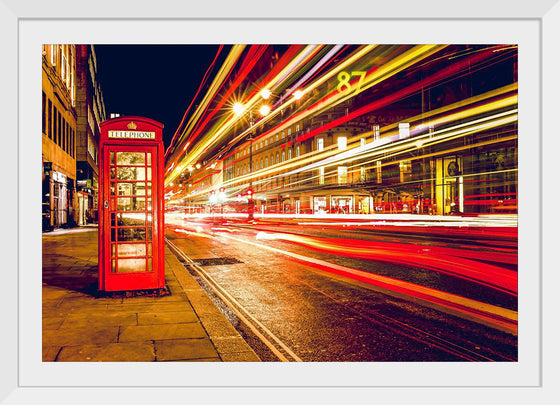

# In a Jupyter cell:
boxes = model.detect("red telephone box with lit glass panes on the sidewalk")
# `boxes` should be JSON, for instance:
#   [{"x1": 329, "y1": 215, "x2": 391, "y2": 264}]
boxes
[{"x1": 98, "y1": 116, "x2": 165, "y2": 291}]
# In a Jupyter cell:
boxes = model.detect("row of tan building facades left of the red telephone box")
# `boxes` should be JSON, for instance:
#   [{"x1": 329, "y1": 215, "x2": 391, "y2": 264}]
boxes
[{"x1": 42, "y1": 44, "x2": 105, "y2": 230}]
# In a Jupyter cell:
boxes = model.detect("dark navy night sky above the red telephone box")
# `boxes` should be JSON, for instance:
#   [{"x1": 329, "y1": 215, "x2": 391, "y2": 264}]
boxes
[{"x1": 95, "y1": 45, "x2": 223, "y2": 148}]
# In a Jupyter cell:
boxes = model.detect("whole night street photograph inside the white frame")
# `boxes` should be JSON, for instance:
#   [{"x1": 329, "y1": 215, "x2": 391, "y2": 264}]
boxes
[{"x1": 43, "y1": 44, "x2": 518, "y2": 362}]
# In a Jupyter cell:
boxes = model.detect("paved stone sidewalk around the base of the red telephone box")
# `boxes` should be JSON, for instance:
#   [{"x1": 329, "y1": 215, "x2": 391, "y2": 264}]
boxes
[{"x1": 43, "y1": 227, "x2": 260, "y2": 361}]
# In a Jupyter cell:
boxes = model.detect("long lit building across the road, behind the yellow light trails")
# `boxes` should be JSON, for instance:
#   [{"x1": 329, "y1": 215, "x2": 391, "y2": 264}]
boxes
[{"x1": 169, "y1": 45, "x2": 517, "y2": 215}]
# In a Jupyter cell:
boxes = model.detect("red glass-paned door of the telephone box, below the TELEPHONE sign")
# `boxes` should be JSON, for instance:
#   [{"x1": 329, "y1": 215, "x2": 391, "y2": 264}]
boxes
[{"x1": 100, "y1": 145, "x2": 163, "y2": 291}]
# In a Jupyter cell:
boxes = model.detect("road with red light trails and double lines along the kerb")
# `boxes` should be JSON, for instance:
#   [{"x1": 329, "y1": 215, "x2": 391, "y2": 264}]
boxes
[{"x1": 162, "y1": 213, "x2": 517, "y2": 361}]
